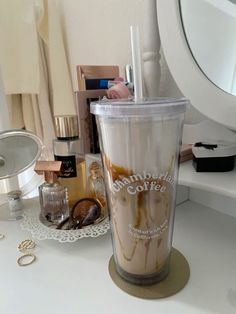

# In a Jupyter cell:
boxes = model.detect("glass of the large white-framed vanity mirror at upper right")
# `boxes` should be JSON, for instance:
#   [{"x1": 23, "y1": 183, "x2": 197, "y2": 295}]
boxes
[{"x1": 180, "y1": 0, "x2": 236, "y2": 95}]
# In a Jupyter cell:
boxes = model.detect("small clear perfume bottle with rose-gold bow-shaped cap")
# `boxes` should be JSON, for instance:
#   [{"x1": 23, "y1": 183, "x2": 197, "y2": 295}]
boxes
[{"x1": 34, "y1": 161, "x2": 69, "y2": 224}]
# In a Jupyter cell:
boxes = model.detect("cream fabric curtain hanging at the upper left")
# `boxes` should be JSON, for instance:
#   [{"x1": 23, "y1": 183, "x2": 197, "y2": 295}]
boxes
[{"x1": 0, "y1": 0, "x2": 75, "y2": 155}]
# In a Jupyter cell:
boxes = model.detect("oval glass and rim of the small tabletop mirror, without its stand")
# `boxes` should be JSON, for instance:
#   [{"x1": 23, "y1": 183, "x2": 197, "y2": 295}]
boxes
[{"x1": 0, "y1": 130, "x2": 42, "y2": 180}]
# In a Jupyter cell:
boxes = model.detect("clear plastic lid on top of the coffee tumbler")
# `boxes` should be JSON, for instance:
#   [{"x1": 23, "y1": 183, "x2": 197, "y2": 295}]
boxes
[{"x1": 90, "y1": 98, "x2": 189, "y2": 117}]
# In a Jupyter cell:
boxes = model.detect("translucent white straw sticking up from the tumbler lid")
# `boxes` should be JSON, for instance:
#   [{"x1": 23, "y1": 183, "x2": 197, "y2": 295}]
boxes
[{"x1": 130, "y1": 25, "x2": 143, "y2": 101}]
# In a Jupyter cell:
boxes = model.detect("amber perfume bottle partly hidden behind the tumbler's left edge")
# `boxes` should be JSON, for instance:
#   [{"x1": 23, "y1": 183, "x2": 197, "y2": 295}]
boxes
[{"x1": 88, "y1": 161, "x2": 107, "y2": 214}]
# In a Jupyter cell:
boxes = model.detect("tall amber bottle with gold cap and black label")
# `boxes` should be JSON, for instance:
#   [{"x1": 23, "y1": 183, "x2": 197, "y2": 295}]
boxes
[{"x1": 53, "y1": 115, "x2": 86, "y2": 208}]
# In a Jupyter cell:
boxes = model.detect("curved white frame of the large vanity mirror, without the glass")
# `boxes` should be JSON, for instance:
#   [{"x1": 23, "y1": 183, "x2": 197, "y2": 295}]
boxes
[{"x1": 156, "y1": 0, "x2": 236, "y2": 130}]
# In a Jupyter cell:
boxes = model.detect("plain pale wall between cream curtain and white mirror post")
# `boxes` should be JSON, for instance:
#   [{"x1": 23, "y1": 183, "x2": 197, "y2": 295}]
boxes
[{"x1": 61, "y1": 0, "x2": 145, "y2": 90}]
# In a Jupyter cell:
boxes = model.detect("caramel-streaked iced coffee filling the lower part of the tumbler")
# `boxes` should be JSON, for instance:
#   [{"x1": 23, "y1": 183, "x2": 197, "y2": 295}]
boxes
[{"x1": 104, "y1": 155, "x2": 174, "y2": 282}]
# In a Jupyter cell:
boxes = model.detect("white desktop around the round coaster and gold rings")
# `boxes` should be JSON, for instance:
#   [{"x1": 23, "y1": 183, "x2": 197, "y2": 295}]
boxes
[{"x1": 0, "y1": 201, "x2": 236, "y2": 314}]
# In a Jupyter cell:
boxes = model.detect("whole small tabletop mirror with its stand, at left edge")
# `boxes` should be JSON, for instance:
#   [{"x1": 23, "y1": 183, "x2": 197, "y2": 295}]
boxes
[{"x1": 0, "y1": 129, "x2": 43, "y2": 220}]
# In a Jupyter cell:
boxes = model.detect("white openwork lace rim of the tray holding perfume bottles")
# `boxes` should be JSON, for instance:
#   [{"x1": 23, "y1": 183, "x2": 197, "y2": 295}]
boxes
[{"x1": 21, "y1": 201, "x2": 110, "y2": 242}]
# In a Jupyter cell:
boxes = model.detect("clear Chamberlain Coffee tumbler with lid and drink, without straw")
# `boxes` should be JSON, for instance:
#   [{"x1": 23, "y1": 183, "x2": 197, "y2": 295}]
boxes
[{"x1": 91, "y1": 99, "x2": 187, "y2": 285}]
